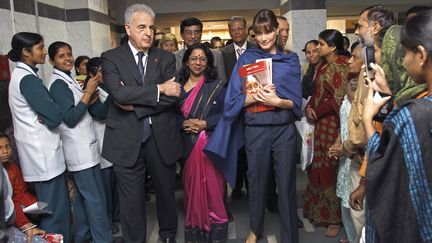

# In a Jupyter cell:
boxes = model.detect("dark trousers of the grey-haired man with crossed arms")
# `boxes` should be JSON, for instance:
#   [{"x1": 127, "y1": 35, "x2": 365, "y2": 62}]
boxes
[{"x1": 114, "y1": 136, "x2": 178, "y2": 243}]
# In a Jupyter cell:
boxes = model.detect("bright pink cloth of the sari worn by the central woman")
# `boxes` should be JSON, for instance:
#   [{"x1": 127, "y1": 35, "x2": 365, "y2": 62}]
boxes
[{"x1": 181, "y1": 78, "x2": 228, "y2": 232}]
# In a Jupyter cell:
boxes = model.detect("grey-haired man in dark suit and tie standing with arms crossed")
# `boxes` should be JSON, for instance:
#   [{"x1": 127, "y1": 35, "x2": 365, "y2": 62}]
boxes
[{"x1": 102, "y1": 4, "x2": 182, "y2": 243}]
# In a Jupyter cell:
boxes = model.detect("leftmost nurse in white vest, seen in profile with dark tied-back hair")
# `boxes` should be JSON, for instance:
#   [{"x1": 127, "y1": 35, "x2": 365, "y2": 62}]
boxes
[{"x1": 8, "y1": 32, "x2": 71, "y2": 242}]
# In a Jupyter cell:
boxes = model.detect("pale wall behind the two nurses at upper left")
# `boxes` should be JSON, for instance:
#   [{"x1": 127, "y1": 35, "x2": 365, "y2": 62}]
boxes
[{"x1": 0, "y1": 0, "x2": 111, "y2": 82}]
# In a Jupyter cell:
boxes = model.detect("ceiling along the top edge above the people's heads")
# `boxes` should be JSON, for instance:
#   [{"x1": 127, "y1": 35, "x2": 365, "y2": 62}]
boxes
[{"x1": 107, "y1": 0, "x2": 432, "y2": 30}]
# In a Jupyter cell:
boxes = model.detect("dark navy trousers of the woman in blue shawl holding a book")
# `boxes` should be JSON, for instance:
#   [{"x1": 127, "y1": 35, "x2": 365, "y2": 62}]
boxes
[{"x1": 245, "y1": 124, "x2": 298, "y2": 243}]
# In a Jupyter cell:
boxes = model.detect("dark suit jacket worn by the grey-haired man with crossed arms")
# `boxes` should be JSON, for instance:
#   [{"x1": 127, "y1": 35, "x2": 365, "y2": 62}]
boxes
[{"x1": 101, "y1": 44, "x2": 183, "y2": 167}]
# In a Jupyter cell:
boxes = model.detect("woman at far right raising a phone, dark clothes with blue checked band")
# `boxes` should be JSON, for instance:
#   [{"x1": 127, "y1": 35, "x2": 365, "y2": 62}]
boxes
[{"x1": 362, "y1": 11, "x2": 432, "y2": 243}]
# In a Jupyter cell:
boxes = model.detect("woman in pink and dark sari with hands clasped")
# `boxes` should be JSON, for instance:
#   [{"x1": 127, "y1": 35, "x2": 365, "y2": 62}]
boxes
[{"x1": 180, "y1": 44, "x2": 228, "y2": 243}]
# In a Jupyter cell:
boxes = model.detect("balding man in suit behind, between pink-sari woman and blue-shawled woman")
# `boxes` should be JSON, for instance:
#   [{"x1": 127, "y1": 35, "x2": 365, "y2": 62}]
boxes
[{"x1": 221, "y1": 16, "x2": 252, "y2": 200}]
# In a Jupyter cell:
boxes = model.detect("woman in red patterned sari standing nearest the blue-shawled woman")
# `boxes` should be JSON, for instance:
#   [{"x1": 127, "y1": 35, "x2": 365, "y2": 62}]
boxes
[{"x1": 304, "y1": 30, "x2": 349, "y2": 237}]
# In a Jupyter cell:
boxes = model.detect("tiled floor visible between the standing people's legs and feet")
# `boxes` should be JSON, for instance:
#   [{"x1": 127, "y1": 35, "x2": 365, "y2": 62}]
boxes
[{"x1": 114, "y1": 169, "x2": 344, "y2": 243}]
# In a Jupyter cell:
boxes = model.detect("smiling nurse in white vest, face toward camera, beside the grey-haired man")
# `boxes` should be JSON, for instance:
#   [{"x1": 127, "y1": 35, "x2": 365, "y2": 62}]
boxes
[{"x1": 48, "y1": 41, "x2": 112, "y2": 243}]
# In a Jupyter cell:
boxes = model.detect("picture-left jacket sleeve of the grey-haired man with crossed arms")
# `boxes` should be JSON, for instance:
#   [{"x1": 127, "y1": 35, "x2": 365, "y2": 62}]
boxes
[{"x1": 101, "y1": 51, "x2": 158, "y2": 107}]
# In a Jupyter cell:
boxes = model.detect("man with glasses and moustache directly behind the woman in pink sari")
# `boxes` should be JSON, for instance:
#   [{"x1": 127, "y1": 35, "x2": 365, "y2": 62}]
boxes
[{"x1": 174, "y1": 17, "x2": 227, "y2": 81}]
